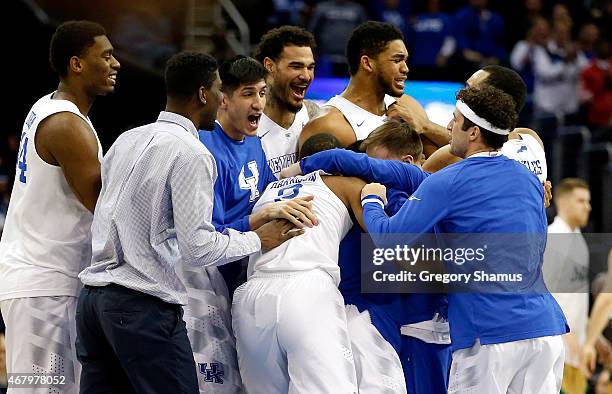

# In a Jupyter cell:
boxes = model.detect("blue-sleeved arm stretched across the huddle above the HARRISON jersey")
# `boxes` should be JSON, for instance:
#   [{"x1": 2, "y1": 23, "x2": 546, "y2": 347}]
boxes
[{"x1": 298, "y1": 149, "x2": 429, "y2": 193}]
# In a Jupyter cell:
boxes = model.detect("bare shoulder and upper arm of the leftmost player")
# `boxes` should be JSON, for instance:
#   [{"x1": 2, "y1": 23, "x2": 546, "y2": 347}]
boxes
[{"x1": 35, "y1": 112, "x2": 102, "y2": 213}]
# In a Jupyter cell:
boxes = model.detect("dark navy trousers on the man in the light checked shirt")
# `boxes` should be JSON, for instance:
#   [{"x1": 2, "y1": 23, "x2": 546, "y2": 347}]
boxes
[{"x1": 76, "y1": 285, "x2": 198, "y2": 394}]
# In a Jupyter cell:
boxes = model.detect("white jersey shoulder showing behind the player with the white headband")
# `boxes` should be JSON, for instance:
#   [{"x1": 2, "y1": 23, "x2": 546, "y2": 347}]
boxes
[{"x1": 501, "y1": 134, "x2": 548, "y2": 183}]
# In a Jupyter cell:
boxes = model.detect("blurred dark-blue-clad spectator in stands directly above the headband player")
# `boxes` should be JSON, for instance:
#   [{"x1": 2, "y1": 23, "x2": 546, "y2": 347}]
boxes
[{"x1": 453, "y1": 0, "x2": 506, "y2": 79}]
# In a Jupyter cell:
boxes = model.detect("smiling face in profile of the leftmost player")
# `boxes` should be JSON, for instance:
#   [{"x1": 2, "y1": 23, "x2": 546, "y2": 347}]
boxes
[{"x1": 79, "y1": 36, "x2": 121, "y2": 96}]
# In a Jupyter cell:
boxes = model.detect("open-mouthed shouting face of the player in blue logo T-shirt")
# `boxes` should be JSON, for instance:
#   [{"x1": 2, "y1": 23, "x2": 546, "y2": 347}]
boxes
[{"x1": 219, "y1": 80, "x2": 266, "y2": 141}]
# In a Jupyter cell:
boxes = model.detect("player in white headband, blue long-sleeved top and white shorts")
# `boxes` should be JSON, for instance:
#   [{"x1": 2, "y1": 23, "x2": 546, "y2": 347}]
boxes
[{"x1": 362, "y1": 86, "x2": 568, "y2": 393}]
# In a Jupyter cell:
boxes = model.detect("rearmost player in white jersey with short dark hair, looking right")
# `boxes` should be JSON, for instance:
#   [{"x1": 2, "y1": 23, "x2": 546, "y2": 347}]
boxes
[{"x1": 300, "y1": 21, "x2": 448, "y2": 154}]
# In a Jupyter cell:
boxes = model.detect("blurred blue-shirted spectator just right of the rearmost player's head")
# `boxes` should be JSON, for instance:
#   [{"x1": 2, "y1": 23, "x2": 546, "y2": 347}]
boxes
[{"x1": 407, "y1": 0, "x2": 451, "y2": 80}]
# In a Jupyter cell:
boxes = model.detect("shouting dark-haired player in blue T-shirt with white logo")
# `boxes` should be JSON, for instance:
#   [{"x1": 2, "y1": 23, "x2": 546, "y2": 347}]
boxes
[{"x1": 179, "y1": 55, "x2": 315, "y2": 393}]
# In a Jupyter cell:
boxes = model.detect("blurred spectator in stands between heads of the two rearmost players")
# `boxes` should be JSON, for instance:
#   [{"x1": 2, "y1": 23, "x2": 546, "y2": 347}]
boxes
[{"x1": 308, "y1": 0, "x2": 368, "y2": 77}]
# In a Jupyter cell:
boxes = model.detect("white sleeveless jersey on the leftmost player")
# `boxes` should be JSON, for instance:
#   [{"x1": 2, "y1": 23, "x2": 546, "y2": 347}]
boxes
[{"x1": 0, "y1": 94, "x2": 102, "y2": 300}]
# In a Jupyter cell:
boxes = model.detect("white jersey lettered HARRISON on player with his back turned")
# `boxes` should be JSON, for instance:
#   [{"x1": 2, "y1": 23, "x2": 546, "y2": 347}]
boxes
[{"x1": 248, "y1": 171, "x2": 353, "y2": 285}]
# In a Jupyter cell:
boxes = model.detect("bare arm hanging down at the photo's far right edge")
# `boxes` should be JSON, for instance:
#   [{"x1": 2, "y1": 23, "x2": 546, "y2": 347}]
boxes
[{"x1": 582, "y1": 249, "x2": 612, "y2": 373}]
